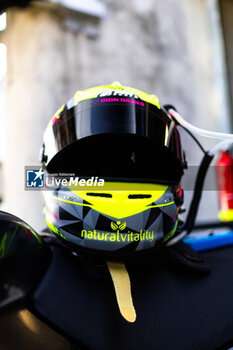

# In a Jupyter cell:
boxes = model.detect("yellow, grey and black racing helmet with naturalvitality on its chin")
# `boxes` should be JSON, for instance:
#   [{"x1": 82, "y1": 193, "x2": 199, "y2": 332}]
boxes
[{"x1": 41, "y1": 82, "x2": 185, "y2": 256}]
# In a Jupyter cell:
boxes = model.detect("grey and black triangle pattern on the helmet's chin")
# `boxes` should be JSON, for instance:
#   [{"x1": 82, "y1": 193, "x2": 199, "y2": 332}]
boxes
[{"x1": 53, "y1": 189, "x2": 178, "y2": 252}]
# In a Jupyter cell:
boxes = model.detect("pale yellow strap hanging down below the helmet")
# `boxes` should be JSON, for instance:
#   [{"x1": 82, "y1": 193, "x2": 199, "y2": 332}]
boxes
[{"x1": 107, "y1": 261, "x2": 136, "y2": 322}]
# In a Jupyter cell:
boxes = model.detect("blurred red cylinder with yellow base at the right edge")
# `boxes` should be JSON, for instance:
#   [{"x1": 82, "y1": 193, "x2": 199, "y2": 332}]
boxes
[{"x1": 216, "y1": 151, "x2": 233, "y2": 221}]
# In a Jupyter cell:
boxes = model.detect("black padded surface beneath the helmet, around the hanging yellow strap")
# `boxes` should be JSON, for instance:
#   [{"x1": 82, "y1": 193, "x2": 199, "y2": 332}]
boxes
[{"x1": 33, "y1": 247, "x2": 233, "y2": 350}]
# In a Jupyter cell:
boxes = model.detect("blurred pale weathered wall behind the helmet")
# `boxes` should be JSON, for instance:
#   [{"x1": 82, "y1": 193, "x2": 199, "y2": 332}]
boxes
[{"x1": 0, "y1": 0, "x2": 233, "y2": 229}]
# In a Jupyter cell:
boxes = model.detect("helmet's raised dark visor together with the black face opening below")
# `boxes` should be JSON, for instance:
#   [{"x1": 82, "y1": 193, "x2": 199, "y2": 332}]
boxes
[{"x1": 45, "y1": 97, "x2": 182, "y2": 182}]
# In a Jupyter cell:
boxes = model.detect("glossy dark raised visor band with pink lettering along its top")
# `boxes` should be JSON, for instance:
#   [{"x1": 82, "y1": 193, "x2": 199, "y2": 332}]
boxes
[{"x1": 53, "y1": 98, "x2": 177, "y2": 151}]
